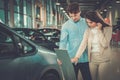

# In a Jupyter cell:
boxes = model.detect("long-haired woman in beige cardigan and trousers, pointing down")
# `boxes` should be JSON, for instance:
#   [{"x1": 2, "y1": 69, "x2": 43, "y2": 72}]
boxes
[{"x1": 71, "y1": 11, "x2": 112, "y2": 80}]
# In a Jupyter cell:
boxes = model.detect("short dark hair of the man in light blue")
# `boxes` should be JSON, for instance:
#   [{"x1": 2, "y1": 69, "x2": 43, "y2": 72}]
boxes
[{"x1": 67, "y1": 2, "x2": 80, "y2": 13}]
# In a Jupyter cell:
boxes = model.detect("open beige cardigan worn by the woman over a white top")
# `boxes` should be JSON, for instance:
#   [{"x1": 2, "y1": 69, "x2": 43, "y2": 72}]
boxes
[{"x1": 75, "y1": 27, "x2": 112, "y2": 61}]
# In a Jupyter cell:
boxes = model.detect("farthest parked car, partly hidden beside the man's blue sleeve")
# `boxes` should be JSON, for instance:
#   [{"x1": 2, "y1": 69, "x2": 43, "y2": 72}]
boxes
[{"x1": 38, "y1": 27, "x2": 61, "y2": 46}]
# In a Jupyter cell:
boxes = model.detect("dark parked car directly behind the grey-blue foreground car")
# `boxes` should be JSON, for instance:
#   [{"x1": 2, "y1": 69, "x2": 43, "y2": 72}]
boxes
[{"x1": 13, "y1": 28, "x2": 58, "y2": 51}]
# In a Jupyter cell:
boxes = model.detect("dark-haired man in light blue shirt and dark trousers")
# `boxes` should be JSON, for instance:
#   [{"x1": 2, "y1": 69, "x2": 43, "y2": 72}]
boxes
[{"x1": 59, "y1": 3, "x2": 91, "y2": 80}]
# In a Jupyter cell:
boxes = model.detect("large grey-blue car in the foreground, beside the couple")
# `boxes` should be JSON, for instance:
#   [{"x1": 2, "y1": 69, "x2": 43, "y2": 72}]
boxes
[{"x1": 0, "y1": 23, "x2": 63, "y2": 80}]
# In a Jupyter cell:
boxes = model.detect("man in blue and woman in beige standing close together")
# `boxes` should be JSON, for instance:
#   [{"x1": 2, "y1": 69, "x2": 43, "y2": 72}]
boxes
[{"x1": 59, "y1": 3, "x2": 112, "y2": 80}]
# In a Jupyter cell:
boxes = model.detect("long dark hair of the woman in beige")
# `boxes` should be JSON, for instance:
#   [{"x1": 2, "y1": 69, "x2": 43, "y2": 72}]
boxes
[{"x1": 85, "y1": 11, "x2": 110, "y2": 30}]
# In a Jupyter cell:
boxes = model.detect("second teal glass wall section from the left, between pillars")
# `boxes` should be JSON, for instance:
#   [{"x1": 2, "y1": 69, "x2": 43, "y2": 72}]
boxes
[{"x1": 14, "y1": 0, "x2": 33, "y2": 28}]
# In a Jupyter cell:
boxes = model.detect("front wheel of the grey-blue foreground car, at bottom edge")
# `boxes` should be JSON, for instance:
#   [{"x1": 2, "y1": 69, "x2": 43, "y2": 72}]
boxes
[{"x1": 40, "y1": 73, "x2": 60, "y2": 80}]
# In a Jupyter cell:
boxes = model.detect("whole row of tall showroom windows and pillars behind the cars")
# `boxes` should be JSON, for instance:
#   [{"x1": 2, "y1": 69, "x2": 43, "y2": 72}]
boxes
[{"x1": 0, "y1": 0, "x2": 69, "y2": 28}]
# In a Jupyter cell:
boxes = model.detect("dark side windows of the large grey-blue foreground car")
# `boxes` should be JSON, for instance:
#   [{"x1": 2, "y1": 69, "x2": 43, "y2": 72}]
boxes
[{"x1": 0, "y1": 30, "x2": 36, "y2": 57}]
